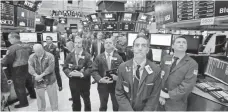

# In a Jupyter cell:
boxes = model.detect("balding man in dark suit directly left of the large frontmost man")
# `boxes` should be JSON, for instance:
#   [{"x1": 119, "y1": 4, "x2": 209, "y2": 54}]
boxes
[{"x1": 92, "y1": 38, "x2": 123, "y2": 111}]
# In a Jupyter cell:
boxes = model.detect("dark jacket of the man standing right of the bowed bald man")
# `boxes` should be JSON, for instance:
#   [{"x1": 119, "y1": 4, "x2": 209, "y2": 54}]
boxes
[{"x1": 63, "y1": 50, "x2": 92, "y2": 81}]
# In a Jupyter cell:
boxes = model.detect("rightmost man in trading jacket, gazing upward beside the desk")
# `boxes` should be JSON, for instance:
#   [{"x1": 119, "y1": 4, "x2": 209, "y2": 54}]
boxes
[{"x1": 159, "y1": 36, "x2": 198, "y2": 111}]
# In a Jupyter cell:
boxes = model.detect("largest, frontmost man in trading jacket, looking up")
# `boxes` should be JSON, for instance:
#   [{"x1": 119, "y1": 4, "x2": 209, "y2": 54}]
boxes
[{"x1": 115, "y1": 36, "x2": 161, "y2": 111}]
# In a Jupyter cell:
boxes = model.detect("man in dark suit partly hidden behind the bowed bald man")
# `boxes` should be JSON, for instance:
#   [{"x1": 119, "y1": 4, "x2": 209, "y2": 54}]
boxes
[{"x1": 44, "y1": 36, "x2": 62, "y2": 91}]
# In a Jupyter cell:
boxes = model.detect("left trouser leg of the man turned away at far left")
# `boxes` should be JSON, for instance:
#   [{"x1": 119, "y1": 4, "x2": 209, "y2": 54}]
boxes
[{"x1": 12, "y1": 65, "x2": 29, "y2": 105}]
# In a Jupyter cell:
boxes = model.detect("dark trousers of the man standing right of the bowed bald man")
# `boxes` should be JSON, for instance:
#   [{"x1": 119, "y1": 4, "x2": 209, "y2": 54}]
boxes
[{"x1": 69, "y1": 78, "x2": 91, "y2": 111}]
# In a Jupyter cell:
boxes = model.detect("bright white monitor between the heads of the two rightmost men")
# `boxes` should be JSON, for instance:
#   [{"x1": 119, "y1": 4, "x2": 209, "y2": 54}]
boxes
[{"x1": 150, "y1": 34, "x2": 172, "y2": 46}]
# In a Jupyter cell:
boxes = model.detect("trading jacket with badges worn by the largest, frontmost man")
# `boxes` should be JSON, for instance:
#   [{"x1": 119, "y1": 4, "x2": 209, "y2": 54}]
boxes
[{"x1": 115, "y1": 59, "x2": 161, "y2": 111}]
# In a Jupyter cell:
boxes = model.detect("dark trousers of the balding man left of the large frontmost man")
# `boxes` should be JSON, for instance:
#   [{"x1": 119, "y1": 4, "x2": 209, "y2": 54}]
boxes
[{"x1": 98, "y1": 84, "x2": 118, "y2": 111}]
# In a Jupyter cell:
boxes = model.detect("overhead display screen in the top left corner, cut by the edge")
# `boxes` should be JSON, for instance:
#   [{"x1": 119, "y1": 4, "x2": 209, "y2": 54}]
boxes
[{"x1": 0, "y1": 2, "x2": 14, "y2": 26}]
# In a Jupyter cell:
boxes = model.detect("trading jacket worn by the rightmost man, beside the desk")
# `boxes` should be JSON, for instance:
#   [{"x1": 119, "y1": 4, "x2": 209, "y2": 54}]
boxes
[{"x1": 161, "y1": 55, "x2": 198, "y2": 111}]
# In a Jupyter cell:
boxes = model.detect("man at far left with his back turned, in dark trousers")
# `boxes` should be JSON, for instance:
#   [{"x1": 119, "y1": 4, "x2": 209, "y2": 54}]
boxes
[{"x1": 1, "y1": 33, "x2": 36, "y2": 108}]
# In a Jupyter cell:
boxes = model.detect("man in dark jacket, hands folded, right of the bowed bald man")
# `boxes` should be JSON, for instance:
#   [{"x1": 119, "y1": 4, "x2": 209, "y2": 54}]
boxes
[{"x1": 63, "y1": 36, "x2": 92, "y2": 111}]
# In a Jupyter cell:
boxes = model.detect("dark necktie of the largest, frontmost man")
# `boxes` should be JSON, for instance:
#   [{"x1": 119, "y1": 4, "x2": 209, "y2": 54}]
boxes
[{"x1": 133, "y1": 65, "x2": 140, "y2": 99}]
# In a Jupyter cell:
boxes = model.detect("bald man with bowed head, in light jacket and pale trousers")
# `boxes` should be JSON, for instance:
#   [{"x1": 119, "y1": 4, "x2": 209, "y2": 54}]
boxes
[{"x1": 28, "y1": 44, "x2": 58, "y2": 111}]
